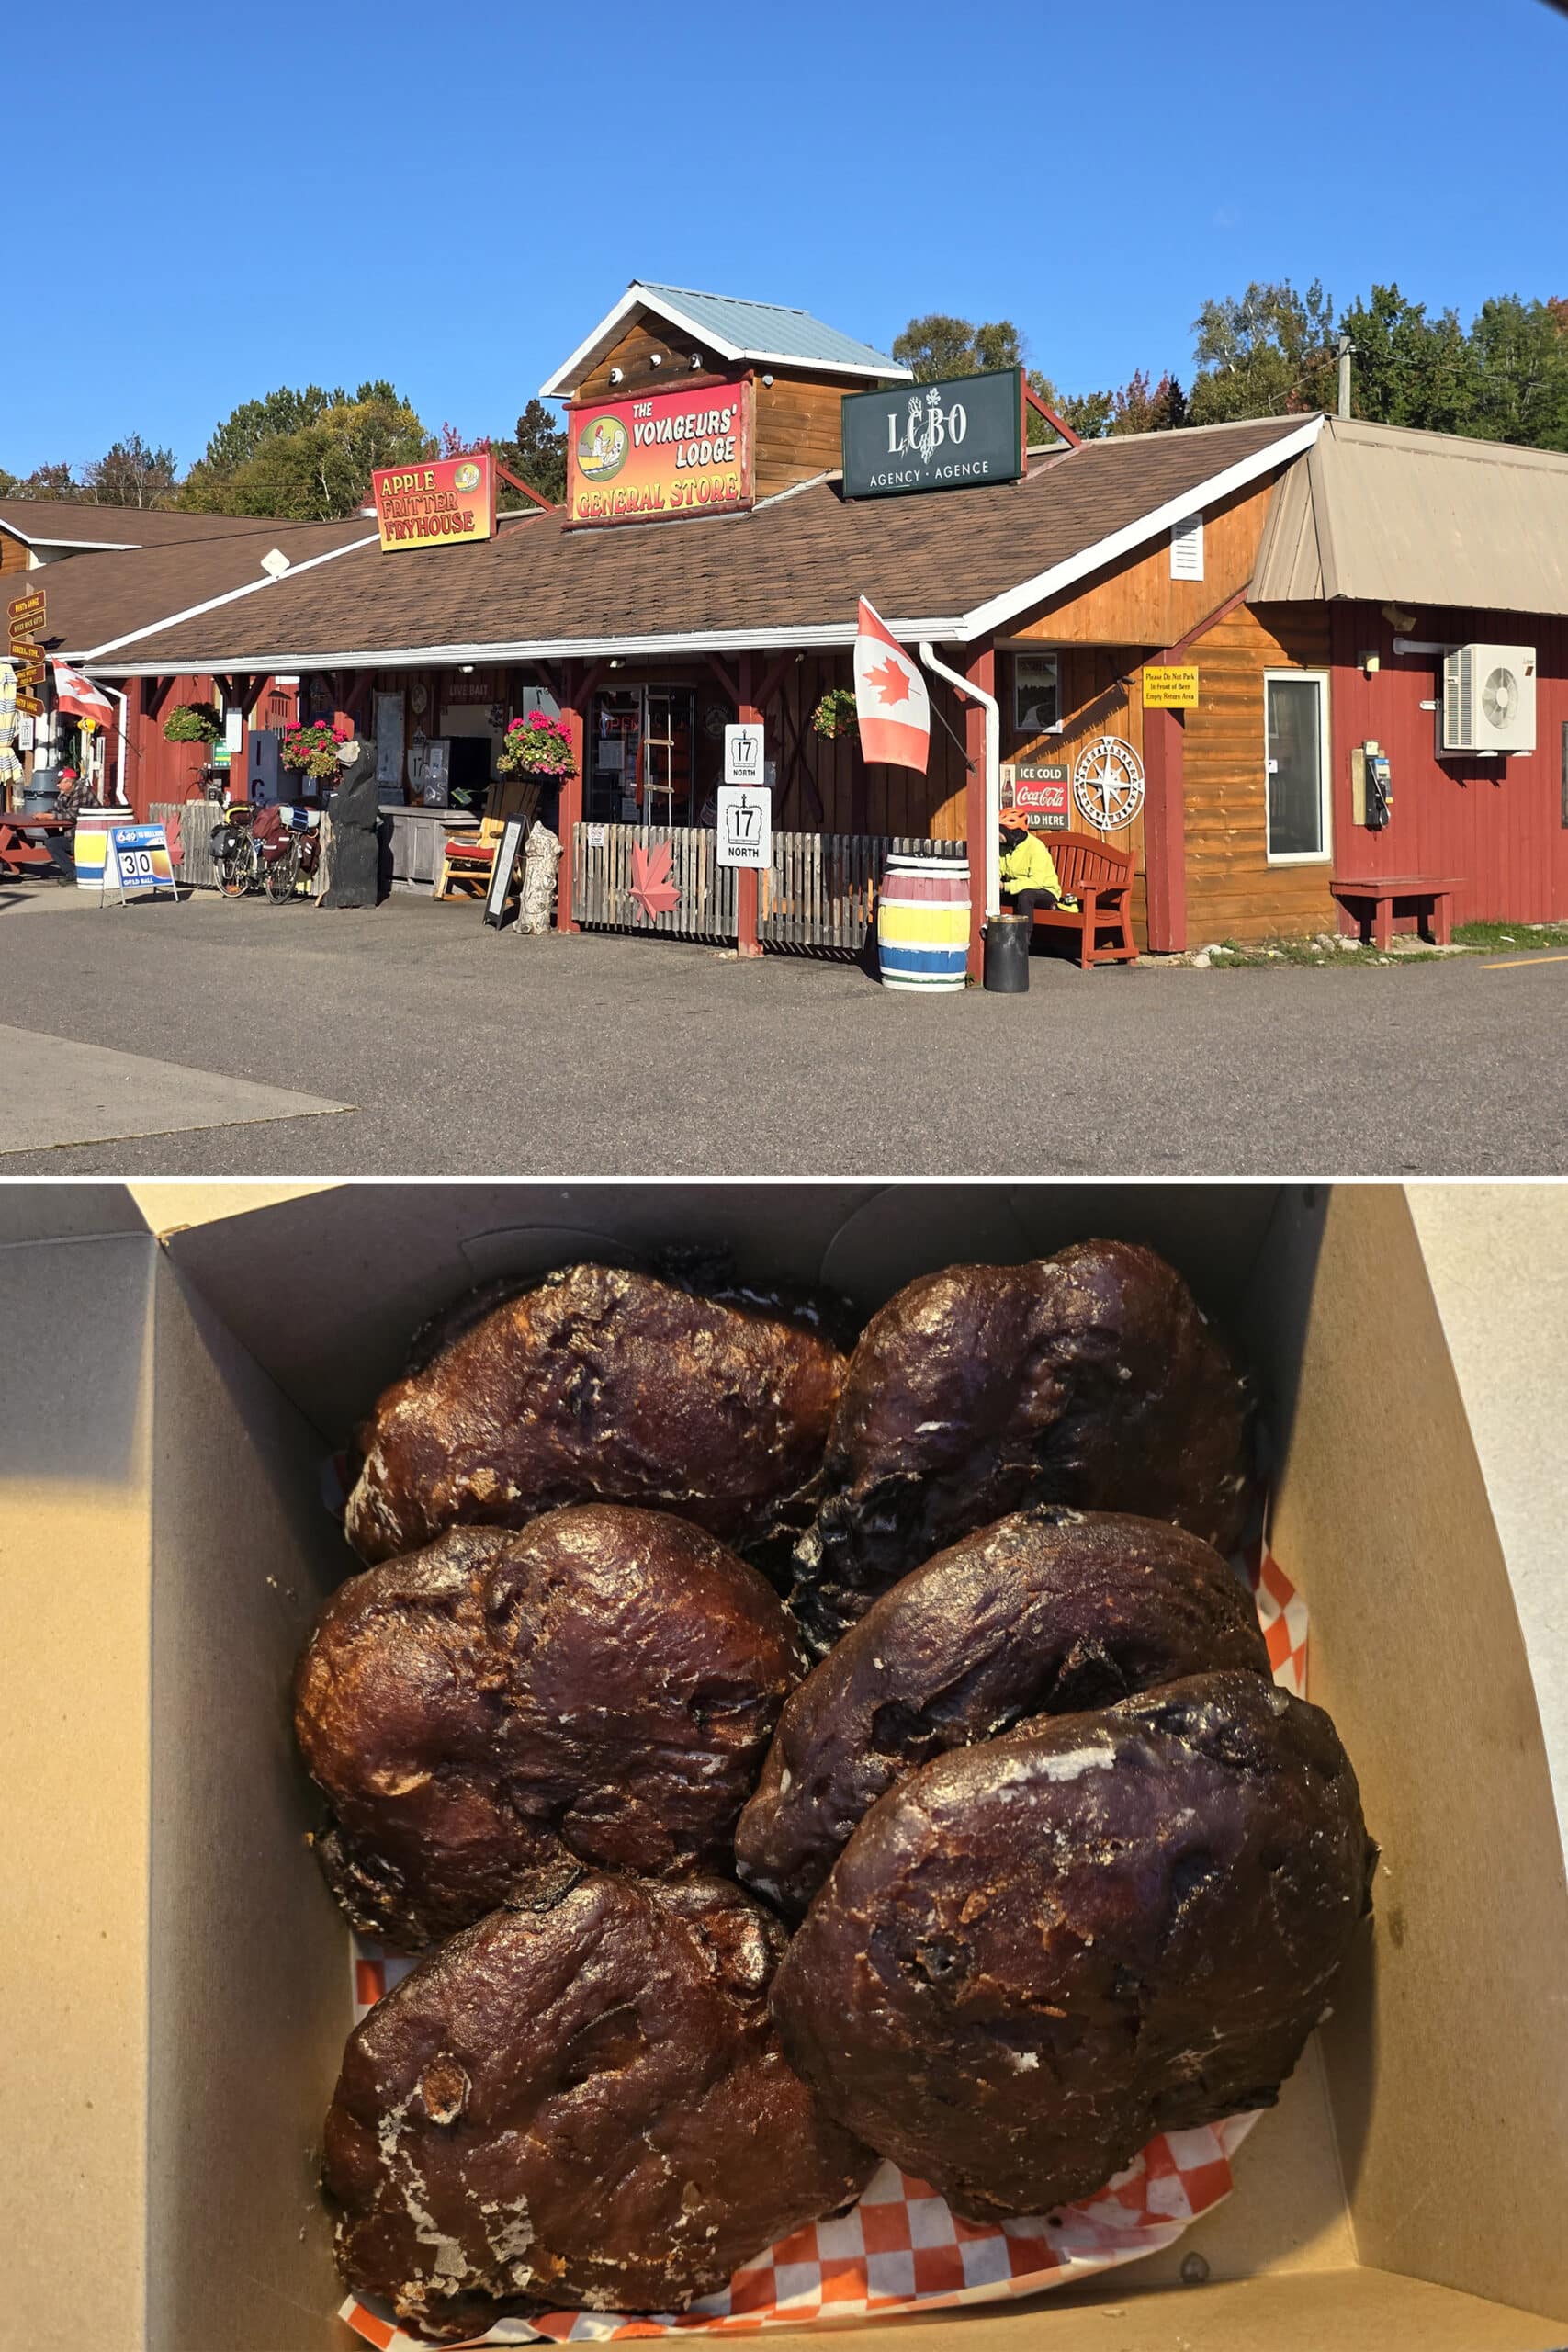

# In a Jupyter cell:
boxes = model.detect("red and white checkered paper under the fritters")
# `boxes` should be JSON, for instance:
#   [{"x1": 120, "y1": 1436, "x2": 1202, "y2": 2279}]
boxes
[{"x1": 339, "y1": 1543, "x2": 1307, "y2": 2352}]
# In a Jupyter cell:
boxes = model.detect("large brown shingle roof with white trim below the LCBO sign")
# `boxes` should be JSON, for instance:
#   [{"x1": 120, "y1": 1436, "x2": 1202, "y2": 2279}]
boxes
[{"x1": 92, "y1": 416, "x2": 1316, "y2": 675}]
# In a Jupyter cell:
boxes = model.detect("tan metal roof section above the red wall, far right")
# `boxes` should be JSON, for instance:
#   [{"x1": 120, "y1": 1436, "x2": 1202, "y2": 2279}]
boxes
[{"x1": 1248, "y1": 416, "x2": 1568, "y2": 614}]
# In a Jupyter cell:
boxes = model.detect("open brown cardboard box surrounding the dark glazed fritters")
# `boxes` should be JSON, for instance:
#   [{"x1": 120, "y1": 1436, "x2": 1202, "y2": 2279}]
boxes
[{"x1": 0, "y1": 1183, "x2": 1568, "y2": 2352}]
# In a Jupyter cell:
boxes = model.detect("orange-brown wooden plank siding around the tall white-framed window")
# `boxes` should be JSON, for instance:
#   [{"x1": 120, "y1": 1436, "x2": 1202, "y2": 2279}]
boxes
[{"x1": 1185, "y1": 605, "x2": 1336, "y2": 948}]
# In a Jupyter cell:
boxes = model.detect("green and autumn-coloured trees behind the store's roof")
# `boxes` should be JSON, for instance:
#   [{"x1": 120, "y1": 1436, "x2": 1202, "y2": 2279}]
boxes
[{"x1": 12, "y1": 277, "x2": 1568, "y2": 522}]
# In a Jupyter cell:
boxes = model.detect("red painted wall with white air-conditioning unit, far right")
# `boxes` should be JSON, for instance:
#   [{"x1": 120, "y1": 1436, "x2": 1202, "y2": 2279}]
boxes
[{"x1": 1333, "y1": 605, "x2": 1568, "y2": 929}]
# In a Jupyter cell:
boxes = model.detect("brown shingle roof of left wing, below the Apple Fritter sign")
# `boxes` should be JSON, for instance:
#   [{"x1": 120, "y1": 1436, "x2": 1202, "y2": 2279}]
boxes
[{"x1": 18, "y1": 515, "x2": 376, "y2": 654}]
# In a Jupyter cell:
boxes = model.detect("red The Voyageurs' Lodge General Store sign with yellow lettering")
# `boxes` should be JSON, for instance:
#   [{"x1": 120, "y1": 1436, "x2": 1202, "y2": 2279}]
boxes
[{"x1": 567, "y1": 383, "x2": 755, "y2": 525}]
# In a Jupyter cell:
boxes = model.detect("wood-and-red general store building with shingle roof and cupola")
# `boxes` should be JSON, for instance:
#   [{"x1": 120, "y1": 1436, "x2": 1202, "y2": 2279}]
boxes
[{"x1": 49, "y1": 285, "x2": 1568, "y2": 957}]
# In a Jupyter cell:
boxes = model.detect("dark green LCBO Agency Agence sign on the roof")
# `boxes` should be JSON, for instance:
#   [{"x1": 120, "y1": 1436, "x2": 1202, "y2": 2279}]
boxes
[{"x1": 844, "y1": 367, "x2": 1022, "y2": 499}]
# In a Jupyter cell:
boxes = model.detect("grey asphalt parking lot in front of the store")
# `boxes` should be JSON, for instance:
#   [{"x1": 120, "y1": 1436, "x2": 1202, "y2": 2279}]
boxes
[{"x1": 0, "y1": 885, "x2": 1568, "y2": 1176}]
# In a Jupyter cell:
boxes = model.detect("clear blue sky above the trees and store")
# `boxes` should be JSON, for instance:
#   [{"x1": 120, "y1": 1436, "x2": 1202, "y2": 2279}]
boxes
[{"x1": 12, "y1": 0, "x2": 1568, "y2": 473}]
